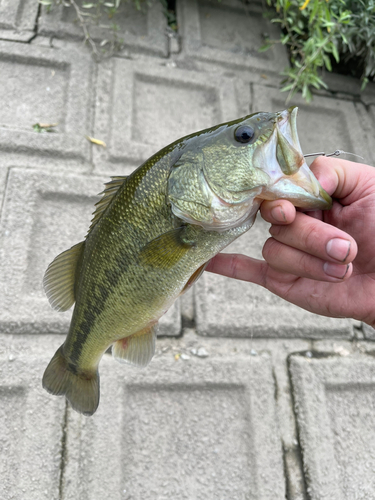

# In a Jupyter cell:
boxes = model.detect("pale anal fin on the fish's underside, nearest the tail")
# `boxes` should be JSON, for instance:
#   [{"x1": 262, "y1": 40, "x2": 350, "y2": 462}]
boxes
[{"x1": 112, "y1": 323, "x2": 157, "y2": 368}]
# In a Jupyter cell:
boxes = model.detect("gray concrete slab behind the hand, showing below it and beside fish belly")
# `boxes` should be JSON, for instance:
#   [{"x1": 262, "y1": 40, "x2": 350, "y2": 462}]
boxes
[{"x1": 195, "y1": 215, "x2": 353, "y2": 338}]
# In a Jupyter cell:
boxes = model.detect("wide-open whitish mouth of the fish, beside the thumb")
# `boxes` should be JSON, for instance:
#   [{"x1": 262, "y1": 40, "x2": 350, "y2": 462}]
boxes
[{"x1": 254, "y1": 107, "x2": 332, "y2": 210}]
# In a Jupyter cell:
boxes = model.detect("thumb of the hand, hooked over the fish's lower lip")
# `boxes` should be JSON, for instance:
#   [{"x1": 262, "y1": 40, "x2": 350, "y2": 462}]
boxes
[{"x1": 310, "y1": 156, "x2": 375, "y2": 205}]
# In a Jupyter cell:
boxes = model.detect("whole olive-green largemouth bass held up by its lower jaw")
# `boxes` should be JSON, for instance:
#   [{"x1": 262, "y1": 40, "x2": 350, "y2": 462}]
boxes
[{"x1": 42, "y1": 107, "x2": 332, "y2": 416}]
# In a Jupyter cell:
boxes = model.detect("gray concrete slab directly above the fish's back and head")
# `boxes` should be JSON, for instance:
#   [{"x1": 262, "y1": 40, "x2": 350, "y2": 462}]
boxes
[{"x1": 94, "y1": 58, "x2": 242, "y2": 174}]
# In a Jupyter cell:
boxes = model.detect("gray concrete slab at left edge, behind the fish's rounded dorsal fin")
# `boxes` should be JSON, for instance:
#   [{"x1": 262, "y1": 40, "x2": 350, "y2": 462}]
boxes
[{"x1": 0, "y1": 169, "x2": 181, "y2": 335}]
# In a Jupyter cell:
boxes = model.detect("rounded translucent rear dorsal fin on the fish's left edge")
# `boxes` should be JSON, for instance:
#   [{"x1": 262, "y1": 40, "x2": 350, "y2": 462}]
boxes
[{"x1": 43, "y1": 241, "x2": 85, "y2": 311}]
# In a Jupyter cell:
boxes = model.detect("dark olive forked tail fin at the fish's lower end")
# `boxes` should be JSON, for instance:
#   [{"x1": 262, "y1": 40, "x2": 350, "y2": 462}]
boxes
[{"x1": 43, "y1": 345, "x2": 100, "y2": 416}]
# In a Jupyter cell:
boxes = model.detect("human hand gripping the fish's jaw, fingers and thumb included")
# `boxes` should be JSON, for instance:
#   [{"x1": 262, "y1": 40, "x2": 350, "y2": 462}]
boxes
[{"x1": 206, "y1": 157, "x2": 375, "y2": 327}]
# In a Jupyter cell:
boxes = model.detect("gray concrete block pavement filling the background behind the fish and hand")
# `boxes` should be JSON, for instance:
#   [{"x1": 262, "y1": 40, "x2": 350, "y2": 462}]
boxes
[{"x1": 0, "y1": 0, "x2": 375, "y2": 500}]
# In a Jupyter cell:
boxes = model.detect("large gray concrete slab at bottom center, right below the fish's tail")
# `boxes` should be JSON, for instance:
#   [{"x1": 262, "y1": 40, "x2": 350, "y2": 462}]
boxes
[{"x1": 62, "y1": 352, "x2": 285, "y2": 500}]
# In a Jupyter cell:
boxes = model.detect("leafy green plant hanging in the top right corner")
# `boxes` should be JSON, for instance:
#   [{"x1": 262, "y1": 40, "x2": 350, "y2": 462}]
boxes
[{"x1": 261, "y1": 0, "x2": 375, "y2": 101}]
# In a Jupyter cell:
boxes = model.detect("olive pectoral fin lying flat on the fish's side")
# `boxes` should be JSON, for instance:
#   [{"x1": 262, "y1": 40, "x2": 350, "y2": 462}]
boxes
[{"x1": 139, "y1": 226, "x2": 195, "y2": 269}]
